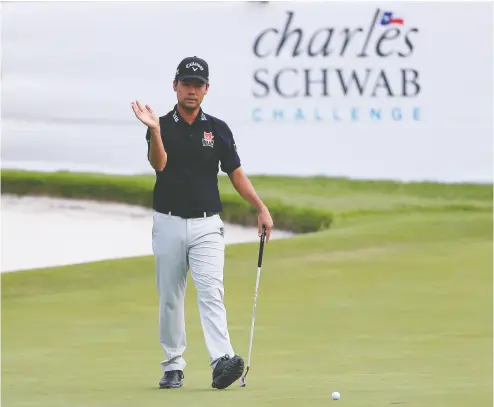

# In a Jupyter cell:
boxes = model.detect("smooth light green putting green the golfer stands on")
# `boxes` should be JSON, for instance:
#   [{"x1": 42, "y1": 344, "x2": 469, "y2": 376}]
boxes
[{"x1": 2, "y1": 173, "x2": 493, "y2": 407}]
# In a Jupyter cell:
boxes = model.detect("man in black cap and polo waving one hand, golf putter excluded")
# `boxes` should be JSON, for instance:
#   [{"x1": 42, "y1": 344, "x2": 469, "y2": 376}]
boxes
[{"x1": 132, "y1": 57, "x2": 273, "y2": 389}]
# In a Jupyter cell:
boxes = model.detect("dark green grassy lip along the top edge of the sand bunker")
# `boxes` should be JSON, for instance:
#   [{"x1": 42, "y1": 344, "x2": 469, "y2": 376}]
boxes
[{"x1": 1, "y1": 170, "x2": 333, "y2": 233}]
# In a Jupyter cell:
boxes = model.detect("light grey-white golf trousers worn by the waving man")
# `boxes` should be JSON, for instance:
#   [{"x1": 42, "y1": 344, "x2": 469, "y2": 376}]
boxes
[{"x1": 152, "y1": 212, "x2": 234, "y2": 371}]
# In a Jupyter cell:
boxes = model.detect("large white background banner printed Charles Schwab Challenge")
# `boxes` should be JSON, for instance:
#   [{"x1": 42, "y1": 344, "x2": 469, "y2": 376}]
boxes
[{"x1": 2, "y1": 2, "x2": 493, "y2": 182}]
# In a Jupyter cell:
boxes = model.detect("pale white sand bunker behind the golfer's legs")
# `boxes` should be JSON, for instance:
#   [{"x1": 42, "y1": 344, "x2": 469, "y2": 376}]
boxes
[{"x1": 1, "y1": 195, "x2": 293, "y2": 272}]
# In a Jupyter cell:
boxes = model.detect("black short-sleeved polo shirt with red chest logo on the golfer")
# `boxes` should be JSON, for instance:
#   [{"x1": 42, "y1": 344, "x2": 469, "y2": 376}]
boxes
[{"x1": 146, "y1": 105, "x2": 240, "y2": 213}]
